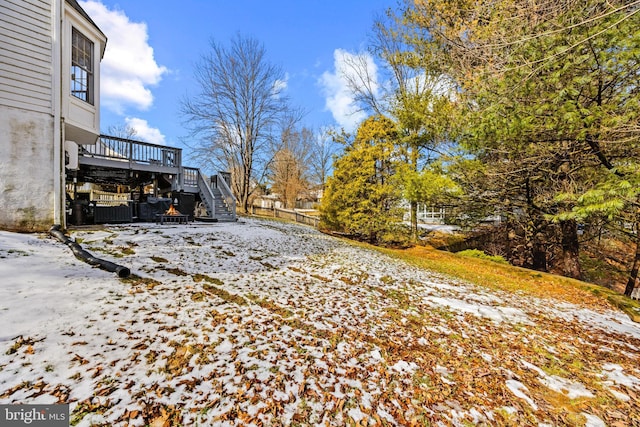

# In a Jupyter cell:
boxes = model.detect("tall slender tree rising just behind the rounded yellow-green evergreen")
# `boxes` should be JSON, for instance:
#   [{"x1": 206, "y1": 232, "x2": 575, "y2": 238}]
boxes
[{"x1": 343, "y1": 12, "x2": 453, "y2": 241}]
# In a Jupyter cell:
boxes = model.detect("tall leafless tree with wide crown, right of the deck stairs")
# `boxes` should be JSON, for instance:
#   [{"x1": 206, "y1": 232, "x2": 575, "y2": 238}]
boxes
[{"x1": 182, "y1": 35, "x2": 287, "y2": 212}]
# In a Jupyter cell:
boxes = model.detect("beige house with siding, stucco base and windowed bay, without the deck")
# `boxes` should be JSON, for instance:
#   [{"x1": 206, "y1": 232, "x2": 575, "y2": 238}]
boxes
[{"x1": 0, "y1": 0, "x2": 107, "y2": 231}]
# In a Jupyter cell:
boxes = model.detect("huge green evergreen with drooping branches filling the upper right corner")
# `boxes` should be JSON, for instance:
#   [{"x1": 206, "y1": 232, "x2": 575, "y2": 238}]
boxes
[{"x1": 403, "y1": 0, "x2": 640, "y2": 277}]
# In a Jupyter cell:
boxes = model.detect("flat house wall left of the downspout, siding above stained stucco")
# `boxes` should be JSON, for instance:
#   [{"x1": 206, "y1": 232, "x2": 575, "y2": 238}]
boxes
[{"x1": 0, "y1": 0, "x2": 60, "y2": 231}]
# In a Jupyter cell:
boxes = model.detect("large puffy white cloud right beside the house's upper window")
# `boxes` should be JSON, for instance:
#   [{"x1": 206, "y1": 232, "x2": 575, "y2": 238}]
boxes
[{"x1": 80, "y1": 0, "x2": 168, "y2": 114}]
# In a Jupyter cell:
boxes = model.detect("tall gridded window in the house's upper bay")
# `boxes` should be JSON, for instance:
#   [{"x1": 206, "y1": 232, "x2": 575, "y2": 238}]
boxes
[{"x1": 71, "y1": 28, "x2": 93, "y2": 105}]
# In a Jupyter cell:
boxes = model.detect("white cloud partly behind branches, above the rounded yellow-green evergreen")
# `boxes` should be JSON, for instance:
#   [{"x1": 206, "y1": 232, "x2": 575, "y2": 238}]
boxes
[{"x1": 319, "y1": 49, "x2": 378, "y2": 132}]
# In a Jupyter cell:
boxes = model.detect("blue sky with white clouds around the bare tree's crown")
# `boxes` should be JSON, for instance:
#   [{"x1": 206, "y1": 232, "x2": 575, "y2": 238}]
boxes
[{"x1": 80, "y1": 0, "x2": 397, "y2": 147}]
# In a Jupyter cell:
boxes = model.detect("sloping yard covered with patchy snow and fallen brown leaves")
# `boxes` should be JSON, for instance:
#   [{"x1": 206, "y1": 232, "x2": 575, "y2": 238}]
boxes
[{"x1": 0, "y1": 219, "x2": 640, "y2": 426}]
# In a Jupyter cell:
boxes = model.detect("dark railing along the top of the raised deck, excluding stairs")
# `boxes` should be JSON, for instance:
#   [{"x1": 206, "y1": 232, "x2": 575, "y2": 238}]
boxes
[{"x1": 80, "y1": 135, "x2": 182, "y2": 168}]
